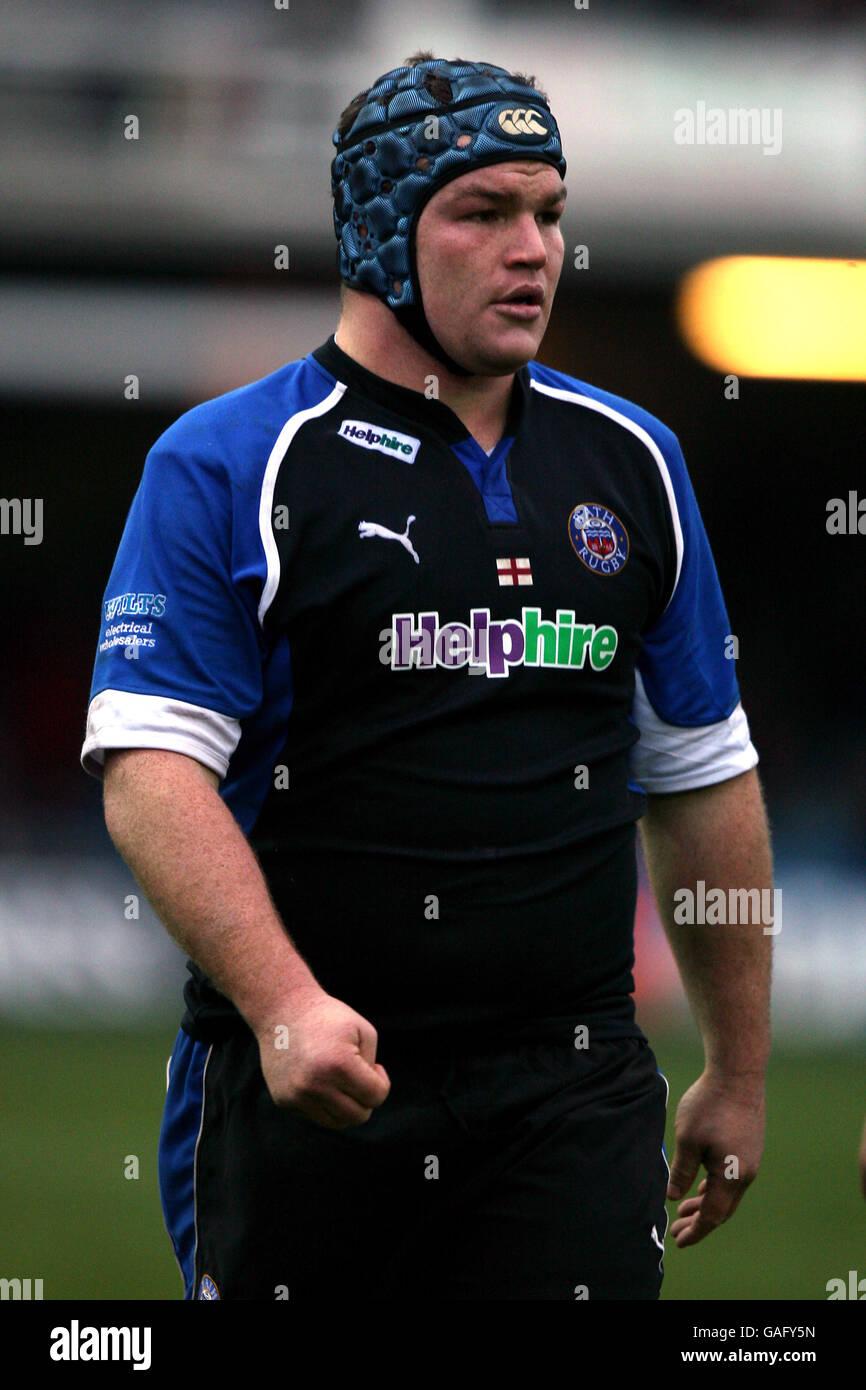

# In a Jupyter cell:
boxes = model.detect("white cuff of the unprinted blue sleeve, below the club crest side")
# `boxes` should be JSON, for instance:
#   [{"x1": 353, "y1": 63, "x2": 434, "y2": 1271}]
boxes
[{"x1": 628, "y1": 671, "x2": 758, "y2": 792}]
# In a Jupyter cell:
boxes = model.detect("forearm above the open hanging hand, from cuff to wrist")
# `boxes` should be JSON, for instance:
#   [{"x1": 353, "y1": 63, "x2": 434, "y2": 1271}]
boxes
[{"x1": 641, "y1": 770, "x2": 774, "y2": 1079}]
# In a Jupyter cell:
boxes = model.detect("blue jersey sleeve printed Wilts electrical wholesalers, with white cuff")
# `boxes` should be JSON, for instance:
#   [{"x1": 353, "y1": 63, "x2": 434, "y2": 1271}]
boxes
[{"x1": 81, "y1": 417, "x2": 264, "y2": 778}]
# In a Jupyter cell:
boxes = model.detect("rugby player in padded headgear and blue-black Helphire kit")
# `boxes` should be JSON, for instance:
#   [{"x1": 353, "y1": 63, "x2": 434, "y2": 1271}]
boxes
[{"x1": 82, "y1": 53, "x2": 770, "y2": 1300}]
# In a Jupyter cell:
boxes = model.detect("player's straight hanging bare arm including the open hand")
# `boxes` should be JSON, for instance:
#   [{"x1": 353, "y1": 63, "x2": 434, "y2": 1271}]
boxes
[{"x1": 641, "y1": 769, "x2": 771, "y2": 1245}]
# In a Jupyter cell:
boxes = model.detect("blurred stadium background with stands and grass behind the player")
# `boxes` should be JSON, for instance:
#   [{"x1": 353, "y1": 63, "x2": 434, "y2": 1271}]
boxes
[{"x1": 0, "y1": 0, "x2": 866, "y2": 1300}]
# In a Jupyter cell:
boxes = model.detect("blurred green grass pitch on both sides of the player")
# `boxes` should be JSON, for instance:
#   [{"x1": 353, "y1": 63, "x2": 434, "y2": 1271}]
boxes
[{"x1": 0, "y1": 1027, "x2": 866, "y2": 1301}]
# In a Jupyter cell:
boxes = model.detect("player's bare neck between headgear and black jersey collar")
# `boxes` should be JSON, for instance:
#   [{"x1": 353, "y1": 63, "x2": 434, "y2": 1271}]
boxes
[{"x1": 335, "y1": 303, "x2": 514, "y2": 450}]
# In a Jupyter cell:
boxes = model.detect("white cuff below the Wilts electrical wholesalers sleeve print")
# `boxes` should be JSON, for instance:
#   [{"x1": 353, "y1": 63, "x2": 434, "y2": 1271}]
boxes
[{"x1": 81, "y1": 689, "x2": 240, "y2": 778}]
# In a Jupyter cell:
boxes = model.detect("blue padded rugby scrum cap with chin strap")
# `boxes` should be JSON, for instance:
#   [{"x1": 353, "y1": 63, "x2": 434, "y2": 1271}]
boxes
[{"x1": 331, "y1": 58, "x2": 566, "y2": 375}]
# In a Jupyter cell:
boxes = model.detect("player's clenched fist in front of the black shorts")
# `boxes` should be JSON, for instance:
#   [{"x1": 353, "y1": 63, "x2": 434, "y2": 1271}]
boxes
[{"x1": 257, "y1": 991, "x2": 391, "y2": 1129}]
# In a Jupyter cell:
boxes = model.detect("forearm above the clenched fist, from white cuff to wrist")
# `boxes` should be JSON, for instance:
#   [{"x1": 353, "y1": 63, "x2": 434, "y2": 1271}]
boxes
[{"x1": 104, "y1": 749, "x2": 321, "y2": 1033}]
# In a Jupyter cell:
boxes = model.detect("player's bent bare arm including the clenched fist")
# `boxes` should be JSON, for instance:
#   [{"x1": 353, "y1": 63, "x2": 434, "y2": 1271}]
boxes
[{"x1": 104, "y1": 748, "x2": 391, "y2": 1129}]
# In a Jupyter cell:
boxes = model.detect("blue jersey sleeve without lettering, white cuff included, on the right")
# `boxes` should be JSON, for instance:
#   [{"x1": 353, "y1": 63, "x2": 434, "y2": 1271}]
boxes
[{"x1": 630, "y1": 431, "x2": 758, "y2": 792}]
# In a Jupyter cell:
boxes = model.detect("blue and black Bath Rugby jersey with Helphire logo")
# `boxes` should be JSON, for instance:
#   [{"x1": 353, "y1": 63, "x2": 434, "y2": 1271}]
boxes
[{"x1": 82, "y1": 336, "x2": 758, "y2": 1040}]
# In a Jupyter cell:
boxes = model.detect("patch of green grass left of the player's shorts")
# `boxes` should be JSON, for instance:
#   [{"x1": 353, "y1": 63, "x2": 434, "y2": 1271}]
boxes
[{"x1": 0, "y1": 1029, "x2": 182, "y2": 1300}]
